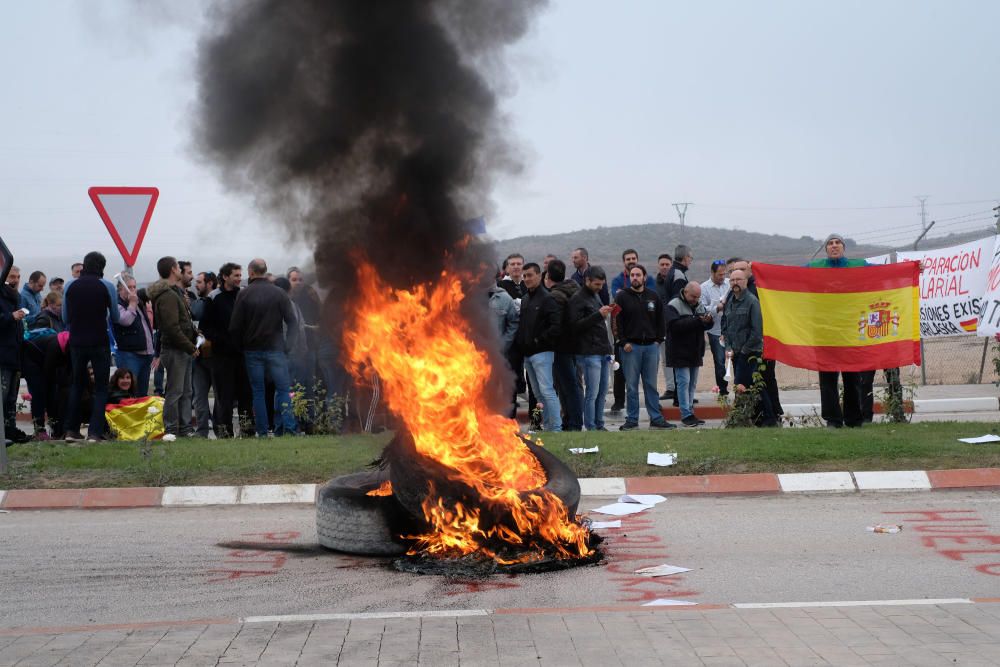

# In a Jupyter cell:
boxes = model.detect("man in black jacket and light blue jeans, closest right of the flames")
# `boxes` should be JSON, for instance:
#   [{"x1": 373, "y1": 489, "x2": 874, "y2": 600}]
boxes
[{"x1": 514, "y1": 262, "x2": 562, "y2": 431}]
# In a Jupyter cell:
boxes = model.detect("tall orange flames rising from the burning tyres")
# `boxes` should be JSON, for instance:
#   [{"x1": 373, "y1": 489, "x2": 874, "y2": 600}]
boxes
[{"x1": 344, "y1": 262, "x2": 591, "y2": 563}]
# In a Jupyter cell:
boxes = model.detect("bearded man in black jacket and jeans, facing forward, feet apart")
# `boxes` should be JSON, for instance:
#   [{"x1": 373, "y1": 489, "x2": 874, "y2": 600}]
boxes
[{"x1": 615, "y1": 264, "x2": 676, "y2": 431}]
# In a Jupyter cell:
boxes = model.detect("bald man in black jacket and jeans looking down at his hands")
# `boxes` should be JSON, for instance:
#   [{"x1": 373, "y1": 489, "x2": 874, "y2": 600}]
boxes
[{"x1": 666, "y1": 282, "x2": 714, "y2": 426}]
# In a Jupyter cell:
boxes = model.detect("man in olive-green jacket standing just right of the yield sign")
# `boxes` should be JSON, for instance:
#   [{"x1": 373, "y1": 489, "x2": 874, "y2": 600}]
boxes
[{"x1": 146, "y1": 256, "x2": 198, "y2": 437}]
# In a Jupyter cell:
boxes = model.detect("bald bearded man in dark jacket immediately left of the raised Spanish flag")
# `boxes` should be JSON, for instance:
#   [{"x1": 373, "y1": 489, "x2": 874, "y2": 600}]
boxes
[{"x1": 721, "y1": 269, "x2": 778, "y2": 426}]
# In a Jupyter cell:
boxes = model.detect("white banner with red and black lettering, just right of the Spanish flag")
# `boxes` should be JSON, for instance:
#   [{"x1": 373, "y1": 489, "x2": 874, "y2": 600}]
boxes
[{"x1": 897, "y1": 236, "x2": 995, "y2": 338}]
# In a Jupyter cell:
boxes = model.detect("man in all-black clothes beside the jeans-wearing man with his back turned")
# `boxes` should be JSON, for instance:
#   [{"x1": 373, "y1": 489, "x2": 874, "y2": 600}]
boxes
[{"x1": 199, "y1": 262, "x2": 251, "y2": 438}]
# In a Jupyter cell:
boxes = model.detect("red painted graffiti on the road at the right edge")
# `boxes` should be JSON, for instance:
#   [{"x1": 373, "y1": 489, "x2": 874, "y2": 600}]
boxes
[{"x1": 885, "y1": 510, "x2": 1000, "y2": 577}]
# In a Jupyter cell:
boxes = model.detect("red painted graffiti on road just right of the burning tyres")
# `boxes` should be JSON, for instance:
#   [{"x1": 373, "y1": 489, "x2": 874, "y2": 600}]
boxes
[{"x1": 604, "y1": 516, "x2": 700, "y2": 602}]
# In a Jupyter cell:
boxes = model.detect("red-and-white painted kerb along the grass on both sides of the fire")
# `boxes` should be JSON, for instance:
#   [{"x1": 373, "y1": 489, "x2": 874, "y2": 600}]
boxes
[{"x1": 0, "y1": 468, "x2": 1000, "y2": 510}]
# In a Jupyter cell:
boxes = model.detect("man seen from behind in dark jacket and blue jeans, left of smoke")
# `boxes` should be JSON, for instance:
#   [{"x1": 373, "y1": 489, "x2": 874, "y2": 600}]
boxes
[{"x1": 229, "y1": 259, "x2": 298, "y2": 438}]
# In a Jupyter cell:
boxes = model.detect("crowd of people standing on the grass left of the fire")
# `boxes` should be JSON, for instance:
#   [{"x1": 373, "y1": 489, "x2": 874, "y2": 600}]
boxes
[{"x1": 0, "y1": 252, "x2": 346, "y2": 442}]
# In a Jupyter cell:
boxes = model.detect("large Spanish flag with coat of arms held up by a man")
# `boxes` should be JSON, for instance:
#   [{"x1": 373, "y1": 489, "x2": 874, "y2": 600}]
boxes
[{"x1": 753, "y1": 262, "x2": 920, "y2": 371}]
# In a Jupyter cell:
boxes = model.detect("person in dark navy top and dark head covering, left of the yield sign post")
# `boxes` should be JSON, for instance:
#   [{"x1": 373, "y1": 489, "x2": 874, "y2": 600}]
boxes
[{"x1": 63, "y1": 252, "x2": 119, "y2": 442}]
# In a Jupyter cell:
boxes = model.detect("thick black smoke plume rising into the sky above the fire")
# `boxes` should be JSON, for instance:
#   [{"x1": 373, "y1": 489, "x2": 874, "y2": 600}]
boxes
[{"x1": 196, "y1": 0, "x2": 543, "y2": 292}]
